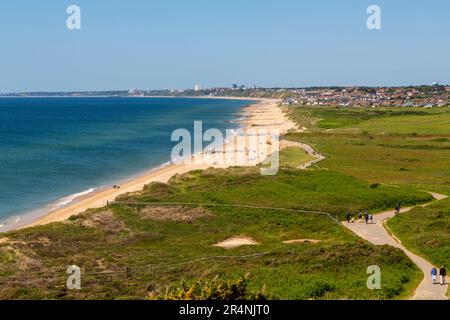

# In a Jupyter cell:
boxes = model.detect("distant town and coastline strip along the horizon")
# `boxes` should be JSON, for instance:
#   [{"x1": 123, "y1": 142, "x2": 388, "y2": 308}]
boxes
[{"x1": 0, "y1": 82, "x2": 450, "y2": 108}]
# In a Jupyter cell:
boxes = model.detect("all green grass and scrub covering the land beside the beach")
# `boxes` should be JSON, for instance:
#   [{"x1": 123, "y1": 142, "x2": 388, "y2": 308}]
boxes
[{"x1": 0, "y1": 103, "x2": 450, "y2": 299}]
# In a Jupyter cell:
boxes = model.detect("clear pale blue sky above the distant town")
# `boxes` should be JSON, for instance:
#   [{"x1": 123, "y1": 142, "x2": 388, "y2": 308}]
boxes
[{"x1": 0, "y1": 0, "x2": 450, "y2": 92}]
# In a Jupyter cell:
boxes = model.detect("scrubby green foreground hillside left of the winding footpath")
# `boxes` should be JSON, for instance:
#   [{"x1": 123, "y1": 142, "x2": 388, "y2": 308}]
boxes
[{"x1": 0, "y1": 168, "x2": 429, "y2": 299}]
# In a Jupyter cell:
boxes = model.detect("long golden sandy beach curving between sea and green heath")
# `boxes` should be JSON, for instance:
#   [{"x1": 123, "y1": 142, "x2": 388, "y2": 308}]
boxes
[{"x1": 12, "y1": 98, "x2": 296, "y2": 229}]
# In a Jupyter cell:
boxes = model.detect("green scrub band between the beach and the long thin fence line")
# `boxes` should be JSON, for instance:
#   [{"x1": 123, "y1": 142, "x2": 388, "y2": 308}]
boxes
[{"x1": 125, "y1": 168, "x2": 432, "y2": 219}]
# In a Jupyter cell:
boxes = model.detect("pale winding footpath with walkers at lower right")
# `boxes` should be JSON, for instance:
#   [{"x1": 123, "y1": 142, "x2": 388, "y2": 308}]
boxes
[{"x1": 343, "y1": 192, "x2": 448, "y2": 300}]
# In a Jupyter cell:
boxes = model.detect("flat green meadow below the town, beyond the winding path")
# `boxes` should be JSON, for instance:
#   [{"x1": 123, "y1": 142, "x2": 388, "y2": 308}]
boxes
[{"x1": 287, "y1": 107, "x2": 450, "y2": 194}]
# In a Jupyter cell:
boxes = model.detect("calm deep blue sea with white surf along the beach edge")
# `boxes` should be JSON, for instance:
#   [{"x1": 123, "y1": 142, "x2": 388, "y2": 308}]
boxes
[{"x1": 0, "y1": 98, "x2": 249, "y2": 231}]
